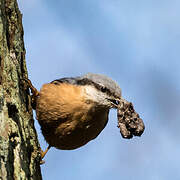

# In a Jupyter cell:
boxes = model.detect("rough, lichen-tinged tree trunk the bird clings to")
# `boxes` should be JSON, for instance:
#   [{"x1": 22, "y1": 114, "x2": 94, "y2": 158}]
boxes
[{"x1": 0, "y1": 0, "x2": 42, "y2": 180}]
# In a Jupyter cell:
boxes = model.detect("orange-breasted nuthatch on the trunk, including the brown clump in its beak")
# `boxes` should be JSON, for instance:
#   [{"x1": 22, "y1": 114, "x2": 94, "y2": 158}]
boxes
[{"x1": 24, "y1": 73, "x2": 144, "y2": 162}]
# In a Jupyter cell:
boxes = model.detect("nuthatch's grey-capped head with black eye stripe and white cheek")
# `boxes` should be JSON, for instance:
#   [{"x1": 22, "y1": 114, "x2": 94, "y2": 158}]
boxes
[{"x1": 77, "y1": 73, "x2": 121, "y2": 109}]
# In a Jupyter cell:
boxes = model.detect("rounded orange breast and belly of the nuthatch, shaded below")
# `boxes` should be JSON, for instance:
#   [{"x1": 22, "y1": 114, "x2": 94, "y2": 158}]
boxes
[{"x1": 36, "y1": 83, "x2": 109, "y2": 149}]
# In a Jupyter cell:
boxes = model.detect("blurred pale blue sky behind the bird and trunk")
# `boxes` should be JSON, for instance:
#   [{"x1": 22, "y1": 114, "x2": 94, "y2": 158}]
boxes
[{"x1": 19, "y1": 0, "x2": 180, "y2": 180}]
